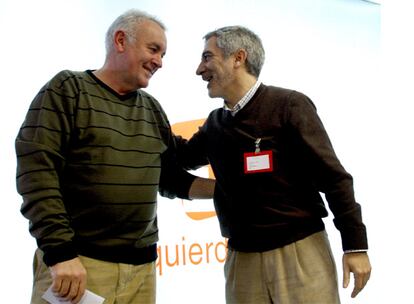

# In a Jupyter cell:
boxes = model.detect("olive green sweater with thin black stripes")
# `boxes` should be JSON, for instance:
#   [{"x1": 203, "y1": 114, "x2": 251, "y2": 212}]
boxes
[{"x1": 16, "y1": 71, "x2": 194, "y2": 265}]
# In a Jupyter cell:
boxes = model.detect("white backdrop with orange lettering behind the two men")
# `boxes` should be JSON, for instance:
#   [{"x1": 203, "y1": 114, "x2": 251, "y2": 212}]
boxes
[{"x1": 0, "y1": 0, "x2": 414, "y2": 304}]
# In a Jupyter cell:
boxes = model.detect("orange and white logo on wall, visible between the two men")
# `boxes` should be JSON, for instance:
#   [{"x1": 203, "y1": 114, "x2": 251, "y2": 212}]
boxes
[{"x1": 171, "y1": 119, "x2": 216, "y2": 221}]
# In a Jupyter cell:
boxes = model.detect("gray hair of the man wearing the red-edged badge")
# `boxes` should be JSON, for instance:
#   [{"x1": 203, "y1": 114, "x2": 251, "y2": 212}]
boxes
[{"x1": 204, "y1": 25, "x2": 265, "y2": 78}]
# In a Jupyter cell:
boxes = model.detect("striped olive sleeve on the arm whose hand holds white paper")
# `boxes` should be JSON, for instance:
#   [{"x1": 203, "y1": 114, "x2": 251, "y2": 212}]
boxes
[{"x1": 15, "y1": 72, "x2": 77, "y2": 266}]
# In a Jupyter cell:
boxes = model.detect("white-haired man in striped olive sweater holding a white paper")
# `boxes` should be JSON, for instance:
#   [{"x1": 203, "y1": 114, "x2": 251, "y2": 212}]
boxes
[{"x1": 16, "y1": 10, "x2": 214, "y2": 304}]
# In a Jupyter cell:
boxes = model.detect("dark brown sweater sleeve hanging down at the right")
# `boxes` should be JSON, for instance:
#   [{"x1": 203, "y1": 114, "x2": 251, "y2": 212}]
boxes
[{"x1": 287, "y1": 92, "x2": 368, "y2": 251}]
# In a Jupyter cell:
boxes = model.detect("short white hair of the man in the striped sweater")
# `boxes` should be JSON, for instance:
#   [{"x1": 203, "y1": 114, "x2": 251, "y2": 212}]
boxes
[{"x1": 105, "y1": 9, "x2": 166, "y2": 53}]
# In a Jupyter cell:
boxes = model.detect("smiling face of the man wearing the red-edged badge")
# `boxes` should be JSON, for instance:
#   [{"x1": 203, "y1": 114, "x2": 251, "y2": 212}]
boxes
[{"x1": 196, "y1": 36, "x2": 235, "y2": 100}]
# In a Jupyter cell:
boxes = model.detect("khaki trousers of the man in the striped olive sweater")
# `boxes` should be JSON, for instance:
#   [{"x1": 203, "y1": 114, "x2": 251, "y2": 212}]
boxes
[{"x1": 31, "y1": 249, "x2": 156, "y2": 304}]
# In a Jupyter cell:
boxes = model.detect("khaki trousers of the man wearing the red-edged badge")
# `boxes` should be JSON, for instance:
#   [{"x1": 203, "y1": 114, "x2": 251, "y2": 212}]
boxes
[{"x1": 224, "y1": 231, "x2": 340, "y2": 304}]
